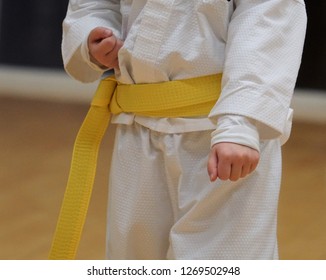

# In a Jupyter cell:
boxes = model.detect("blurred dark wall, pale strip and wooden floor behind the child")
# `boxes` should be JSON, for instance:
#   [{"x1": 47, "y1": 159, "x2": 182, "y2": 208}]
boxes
[{"x1": 0, "y1": 0, "x2": 326, "y2": 260}]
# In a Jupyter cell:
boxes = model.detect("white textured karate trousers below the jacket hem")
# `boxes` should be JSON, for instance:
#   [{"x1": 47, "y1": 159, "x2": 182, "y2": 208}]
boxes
[{"x1": 107, "y1": 123, "x2": 281, "y2": 260}]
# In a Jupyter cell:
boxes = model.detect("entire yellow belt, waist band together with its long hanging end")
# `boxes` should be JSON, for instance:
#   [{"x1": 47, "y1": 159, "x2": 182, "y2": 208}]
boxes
[{"x1": 49, "y1": 74, "x2": 222, "y2": 260}]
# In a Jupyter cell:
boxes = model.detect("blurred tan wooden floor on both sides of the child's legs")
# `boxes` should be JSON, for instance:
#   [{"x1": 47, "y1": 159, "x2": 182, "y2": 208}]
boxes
[{"x1": 0, "y1": 98, "x2": 326, "y2": 260}]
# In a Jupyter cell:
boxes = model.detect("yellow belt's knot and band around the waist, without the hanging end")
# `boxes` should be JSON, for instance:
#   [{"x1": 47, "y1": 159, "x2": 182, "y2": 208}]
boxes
[{"x1": 92, "y1": 74, "x2": 222, "y2": 118}]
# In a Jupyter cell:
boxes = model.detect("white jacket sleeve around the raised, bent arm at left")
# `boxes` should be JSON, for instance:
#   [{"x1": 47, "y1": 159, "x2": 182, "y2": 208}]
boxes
[{"x1": 62, "y1": 0, "x2": 121, "y2": 82}]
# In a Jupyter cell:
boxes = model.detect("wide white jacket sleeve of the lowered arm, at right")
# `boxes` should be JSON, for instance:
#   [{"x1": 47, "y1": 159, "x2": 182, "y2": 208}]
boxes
[{"x1": 210, "y1": 0, "x2": 307, "y2": 139}]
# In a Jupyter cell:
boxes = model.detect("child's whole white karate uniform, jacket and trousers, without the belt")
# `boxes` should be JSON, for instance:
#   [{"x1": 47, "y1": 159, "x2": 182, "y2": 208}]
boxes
[{"x1": 63, "y1": 0, "x2": 306, "y2": 259}]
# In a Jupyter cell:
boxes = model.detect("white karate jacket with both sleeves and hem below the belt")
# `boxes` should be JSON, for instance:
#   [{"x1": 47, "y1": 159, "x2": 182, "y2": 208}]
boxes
[{"x1": 62, "y1": 0, "x2": 307, "y2": 149}]
